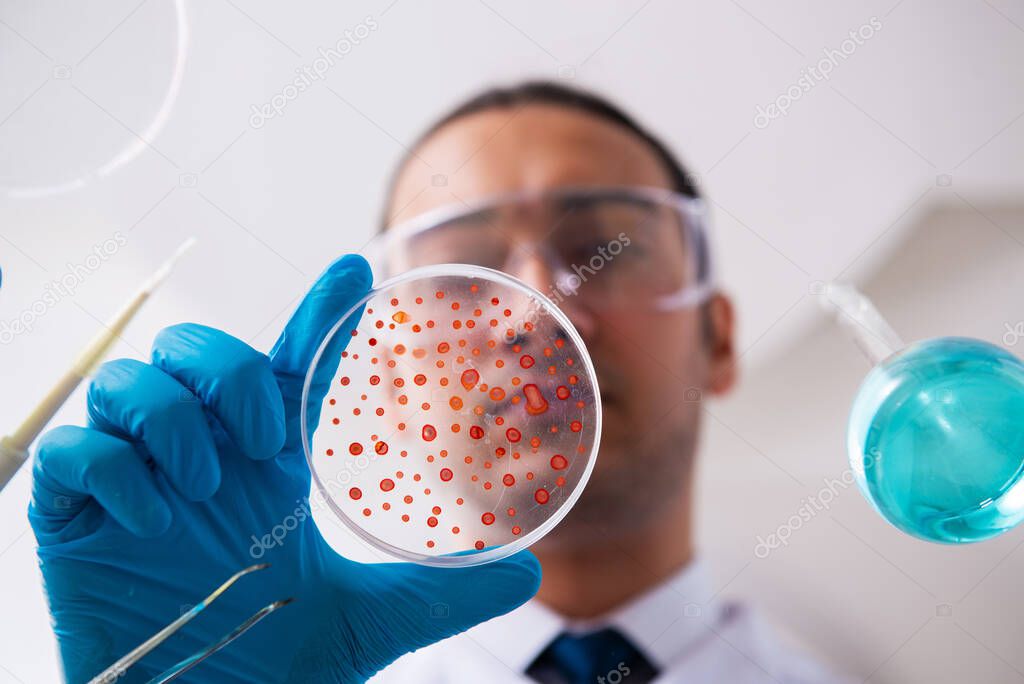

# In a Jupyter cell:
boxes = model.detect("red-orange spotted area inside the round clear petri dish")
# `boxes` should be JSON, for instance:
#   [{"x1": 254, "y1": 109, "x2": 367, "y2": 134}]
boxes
[{"x1": 314, "y1": 281, "x2": 593, "y2": 554}]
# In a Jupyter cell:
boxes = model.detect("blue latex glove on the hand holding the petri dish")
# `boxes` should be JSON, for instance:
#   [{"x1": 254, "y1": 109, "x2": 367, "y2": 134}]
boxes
[{"x1": 29, "y1": 256, "x2": 540, "y2": 682}]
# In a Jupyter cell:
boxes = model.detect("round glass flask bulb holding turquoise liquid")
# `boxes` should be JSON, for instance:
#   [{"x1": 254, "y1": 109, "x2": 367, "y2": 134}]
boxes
[{"x1": 848, "y1": 337, "x2": 1024, "y2": 544}]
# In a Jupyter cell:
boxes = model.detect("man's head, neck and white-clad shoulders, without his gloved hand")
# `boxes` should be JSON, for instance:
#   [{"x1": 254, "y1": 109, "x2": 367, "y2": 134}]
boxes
[{"x1": 375, "y1": 83, "x2": 847, "y2": 684}]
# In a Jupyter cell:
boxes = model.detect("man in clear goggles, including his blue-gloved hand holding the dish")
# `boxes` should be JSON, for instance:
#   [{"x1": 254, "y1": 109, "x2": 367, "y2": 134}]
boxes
[{"x1": 29, "y1": 85, "x2": 847, "y2": 684}]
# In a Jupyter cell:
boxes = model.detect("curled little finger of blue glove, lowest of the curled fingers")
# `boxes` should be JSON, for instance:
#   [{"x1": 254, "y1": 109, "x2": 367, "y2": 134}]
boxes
[{"x1": 29, "y1": 425, "x2": 171, "y2": 538}]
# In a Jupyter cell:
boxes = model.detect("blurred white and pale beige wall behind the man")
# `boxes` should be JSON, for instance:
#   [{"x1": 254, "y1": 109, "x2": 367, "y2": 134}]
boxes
[{"x1": 0, "y1": 0, "x2": 1024, "y2": 683}]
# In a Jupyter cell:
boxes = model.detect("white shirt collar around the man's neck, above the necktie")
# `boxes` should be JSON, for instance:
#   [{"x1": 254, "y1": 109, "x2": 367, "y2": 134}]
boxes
[{"x1": 466, "y1": 561, "x2": 718, "y2": 672}]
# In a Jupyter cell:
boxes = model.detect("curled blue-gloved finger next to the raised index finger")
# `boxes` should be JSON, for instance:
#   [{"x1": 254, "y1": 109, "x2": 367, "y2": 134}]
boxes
[{"x1": 153, "y1": 323, "x2": 285, "y2": 461}]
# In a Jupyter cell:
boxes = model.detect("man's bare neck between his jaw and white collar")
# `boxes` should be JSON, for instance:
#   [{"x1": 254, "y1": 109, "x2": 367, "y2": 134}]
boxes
[{"x1": 535, "y1": 501, "x2": 693, "y2": 619}]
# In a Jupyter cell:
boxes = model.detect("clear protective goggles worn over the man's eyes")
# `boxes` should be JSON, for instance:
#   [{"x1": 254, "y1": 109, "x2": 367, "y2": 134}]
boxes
[{"x1": 370, "y1": 186, "x2": 713, "y2": 310}]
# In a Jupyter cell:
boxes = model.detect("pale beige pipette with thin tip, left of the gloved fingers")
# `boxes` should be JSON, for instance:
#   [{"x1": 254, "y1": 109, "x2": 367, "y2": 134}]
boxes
[{"x1": 0, "y1": 238, "x2": 196, "y2": 490}]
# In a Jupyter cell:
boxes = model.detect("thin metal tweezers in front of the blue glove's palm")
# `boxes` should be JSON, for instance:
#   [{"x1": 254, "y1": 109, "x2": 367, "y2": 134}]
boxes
[{"x1": 89, "y1": 563, "x2": 294, "y2": 684}]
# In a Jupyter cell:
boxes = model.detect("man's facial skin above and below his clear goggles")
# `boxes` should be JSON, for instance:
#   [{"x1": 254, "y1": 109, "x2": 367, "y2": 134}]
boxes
[{"x1": 387, "y1": 104, "x2": 732, "y2": 545}]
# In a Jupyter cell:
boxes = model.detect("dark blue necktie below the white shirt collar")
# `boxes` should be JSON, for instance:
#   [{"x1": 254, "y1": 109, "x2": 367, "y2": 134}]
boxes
[{"x1": 526, "y1": 629, "x2": 657, "y2": 684}]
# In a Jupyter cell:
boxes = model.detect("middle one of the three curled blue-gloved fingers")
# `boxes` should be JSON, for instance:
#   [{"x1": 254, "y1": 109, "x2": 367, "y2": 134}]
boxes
[{"x1": 87, "y1": 358, "x2": 220, "y2": 501}]
